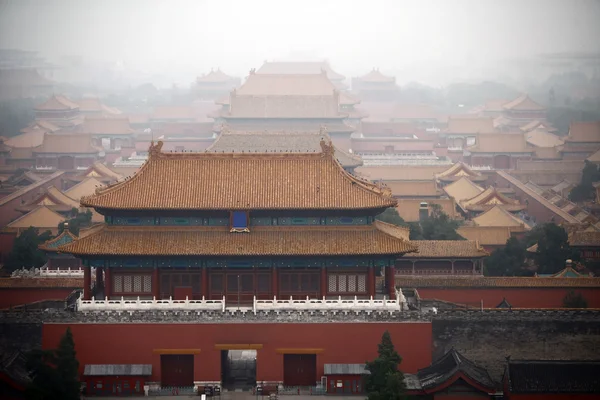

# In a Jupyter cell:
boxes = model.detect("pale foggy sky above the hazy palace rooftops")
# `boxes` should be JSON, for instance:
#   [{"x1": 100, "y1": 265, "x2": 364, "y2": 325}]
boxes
[{"x1": 0, "y1": 0, "x2": 600, "y2": 85}]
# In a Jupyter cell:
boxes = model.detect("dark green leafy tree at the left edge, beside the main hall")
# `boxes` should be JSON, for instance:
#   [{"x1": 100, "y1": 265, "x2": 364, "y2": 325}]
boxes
[{"x1": 5, "y1": 226, "x2": 52, "y2": 272}]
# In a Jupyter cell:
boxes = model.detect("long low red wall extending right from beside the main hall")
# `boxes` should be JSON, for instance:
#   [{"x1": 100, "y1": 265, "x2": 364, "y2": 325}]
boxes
[{"x1": 417, "y1": 288, "x2": 600, "y2": 308}]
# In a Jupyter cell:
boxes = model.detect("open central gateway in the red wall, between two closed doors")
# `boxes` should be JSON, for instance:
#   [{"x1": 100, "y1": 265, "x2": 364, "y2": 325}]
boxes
[{"x1": 221, "y1": 350, "x2": 256, "y2": 390}]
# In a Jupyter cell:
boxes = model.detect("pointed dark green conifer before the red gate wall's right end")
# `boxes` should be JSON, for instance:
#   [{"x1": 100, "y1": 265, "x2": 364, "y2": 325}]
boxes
[{"x1": 365, "y1": 331, "x2": 406, "y2": 400}]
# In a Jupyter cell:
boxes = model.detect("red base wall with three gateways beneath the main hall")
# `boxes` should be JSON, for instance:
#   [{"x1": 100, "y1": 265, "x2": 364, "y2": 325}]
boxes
[{"x1": 42, "y1": 322, "x2": 432, "y2": 381}]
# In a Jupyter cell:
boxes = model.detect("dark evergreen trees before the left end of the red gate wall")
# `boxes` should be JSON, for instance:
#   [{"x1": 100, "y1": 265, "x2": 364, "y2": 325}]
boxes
[{"x1": 27, "y1": 328, "x2": 81, "y2": 400}]
